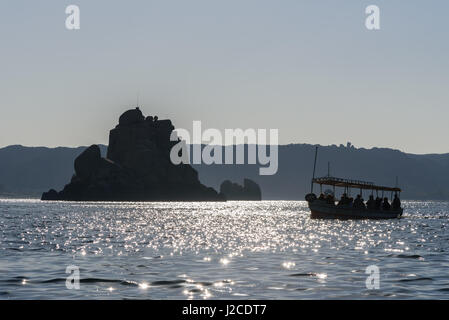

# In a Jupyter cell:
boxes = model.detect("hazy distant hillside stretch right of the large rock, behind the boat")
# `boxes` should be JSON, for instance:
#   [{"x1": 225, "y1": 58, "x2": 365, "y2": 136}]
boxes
[{"x1": 194, "y1": 144, "x2": 449, "y2": 200}]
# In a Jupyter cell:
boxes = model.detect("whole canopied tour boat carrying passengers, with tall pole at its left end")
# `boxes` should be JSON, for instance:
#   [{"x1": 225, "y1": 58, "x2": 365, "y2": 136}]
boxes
[{"x1": 305, "y1": 147, "x2": 403, "y2": 219}]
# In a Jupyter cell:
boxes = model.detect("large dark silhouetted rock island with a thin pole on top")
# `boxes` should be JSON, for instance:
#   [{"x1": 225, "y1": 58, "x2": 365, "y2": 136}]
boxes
[{"x1": 42, "y1": 108, "x2": 225, "y2": 201}]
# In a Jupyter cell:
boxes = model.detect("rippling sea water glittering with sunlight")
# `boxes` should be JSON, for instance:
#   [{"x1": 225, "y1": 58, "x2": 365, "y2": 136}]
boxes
[{"x1": 0, "y1": 200, "x2": 449, "y2": 299}]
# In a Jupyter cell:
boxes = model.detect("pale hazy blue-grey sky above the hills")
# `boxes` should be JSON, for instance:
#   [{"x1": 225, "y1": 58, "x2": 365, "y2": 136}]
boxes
[{"x1": 0, "y1": 0, "x2": 449, "y2": 153}]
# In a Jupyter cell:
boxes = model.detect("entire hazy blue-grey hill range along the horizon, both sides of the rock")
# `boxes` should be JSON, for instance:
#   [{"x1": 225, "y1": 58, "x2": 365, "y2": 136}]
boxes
[{"x1": 0, "y1": 144, "x2": 449, "y2": 200}]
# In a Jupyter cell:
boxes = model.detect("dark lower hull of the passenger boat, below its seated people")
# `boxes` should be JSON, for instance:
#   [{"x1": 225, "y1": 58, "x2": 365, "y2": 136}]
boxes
[{"x1": 308, "y1": 200, "x2": 403, "y2": 219}]
